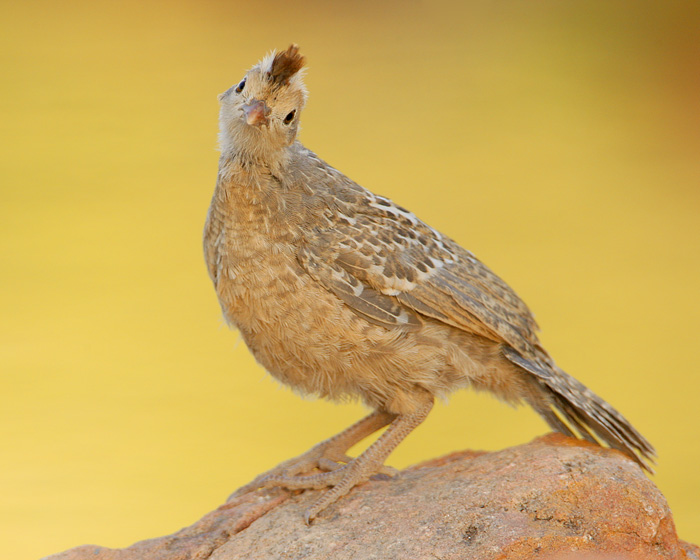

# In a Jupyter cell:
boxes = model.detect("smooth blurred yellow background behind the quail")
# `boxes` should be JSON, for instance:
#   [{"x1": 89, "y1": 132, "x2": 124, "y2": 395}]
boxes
[{"x1": 0, "y1": 0, "x2": 700, "y2": 560}]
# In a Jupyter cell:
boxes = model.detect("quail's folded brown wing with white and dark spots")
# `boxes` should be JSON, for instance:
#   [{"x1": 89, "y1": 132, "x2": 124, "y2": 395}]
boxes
[{"x1": 298, "y1": 191, "x2": 539, "y2": 354}]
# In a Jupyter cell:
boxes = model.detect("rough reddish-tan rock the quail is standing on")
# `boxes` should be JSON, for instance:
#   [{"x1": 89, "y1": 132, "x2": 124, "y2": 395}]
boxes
[{"x1": 47, "y1": 435, "x2": 700, "y2": 560}]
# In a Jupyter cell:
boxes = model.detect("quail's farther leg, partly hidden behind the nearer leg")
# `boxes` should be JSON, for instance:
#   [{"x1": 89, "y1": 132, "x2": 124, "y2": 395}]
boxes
[{"x1": 229, "y1": 410, "x2": 396, "y2": 500}]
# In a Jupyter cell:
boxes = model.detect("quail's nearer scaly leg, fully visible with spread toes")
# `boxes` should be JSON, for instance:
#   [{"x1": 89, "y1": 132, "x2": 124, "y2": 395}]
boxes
[{"x1": 260, "y1": 397, "x2": 433, "y2": 524}]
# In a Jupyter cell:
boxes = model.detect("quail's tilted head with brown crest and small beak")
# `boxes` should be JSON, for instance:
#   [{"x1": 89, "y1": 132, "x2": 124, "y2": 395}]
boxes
[{"x1": 219, "y1": 45, "x2": 307, "y2": 159}]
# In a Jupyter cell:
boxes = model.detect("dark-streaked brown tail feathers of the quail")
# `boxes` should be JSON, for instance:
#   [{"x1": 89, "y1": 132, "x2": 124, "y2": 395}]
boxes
[{"x1": 505, "y1": 348, "x2": 656, "y2": 472}]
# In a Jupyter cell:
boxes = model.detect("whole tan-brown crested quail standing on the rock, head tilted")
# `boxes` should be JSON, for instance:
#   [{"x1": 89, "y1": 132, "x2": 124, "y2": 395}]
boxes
[{"x1": 204, "y1": 44, "x2": 656, "y2": 524}]
